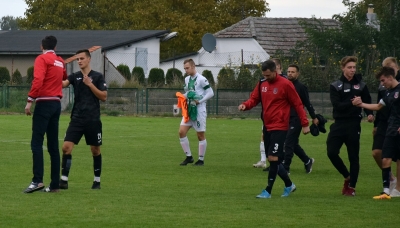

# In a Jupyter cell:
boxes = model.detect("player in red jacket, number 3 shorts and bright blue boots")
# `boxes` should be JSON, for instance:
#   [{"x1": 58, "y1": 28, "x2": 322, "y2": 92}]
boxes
[{"x1": 238, "y1": 60, "x2": 310, "y2": 198}]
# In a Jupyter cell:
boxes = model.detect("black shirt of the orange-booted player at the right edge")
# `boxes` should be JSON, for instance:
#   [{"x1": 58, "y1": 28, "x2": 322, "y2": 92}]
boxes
[{"x1": 382, "y1": 84, "x2": 400, "y2": 136}]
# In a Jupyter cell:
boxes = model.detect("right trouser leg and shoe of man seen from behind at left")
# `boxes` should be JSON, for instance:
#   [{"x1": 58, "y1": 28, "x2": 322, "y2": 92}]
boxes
[{"x1": 44, "y1": 101, "x2": 61, "y2": 192}]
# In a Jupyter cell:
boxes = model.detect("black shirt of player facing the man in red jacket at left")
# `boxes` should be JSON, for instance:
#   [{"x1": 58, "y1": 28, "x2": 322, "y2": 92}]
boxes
[{"x1": 68, "y1": 70, "x2": 107, "y2": 122}]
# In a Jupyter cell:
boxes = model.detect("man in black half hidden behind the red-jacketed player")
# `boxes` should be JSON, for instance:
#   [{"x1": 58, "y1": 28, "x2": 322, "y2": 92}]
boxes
[{"x1": 283, "y1": 64, "x2": 319, "y2": 173}]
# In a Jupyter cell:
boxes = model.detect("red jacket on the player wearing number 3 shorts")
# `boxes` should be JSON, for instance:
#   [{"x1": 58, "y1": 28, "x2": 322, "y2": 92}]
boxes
[{"x1": 243, "y1": 75, "x2": 308, "y2": 131}]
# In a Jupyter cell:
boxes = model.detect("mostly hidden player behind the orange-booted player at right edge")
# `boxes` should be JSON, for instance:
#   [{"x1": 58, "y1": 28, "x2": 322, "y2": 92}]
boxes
[{"x1": 372, "y1": 57, "x2": 400, "y2": 196}]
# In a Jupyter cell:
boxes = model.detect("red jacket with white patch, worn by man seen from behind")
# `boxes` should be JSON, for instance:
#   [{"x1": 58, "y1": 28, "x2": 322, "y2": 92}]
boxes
[{"x1": 28, "y1": 50, "x2": 67, "y2": 101}]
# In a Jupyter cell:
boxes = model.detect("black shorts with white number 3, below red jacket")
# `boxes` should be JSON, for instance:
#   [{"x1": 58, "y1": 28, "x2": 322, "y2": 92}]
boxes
[{"x1": 263, "y1": 130, "x2": 287, "y2": 161}]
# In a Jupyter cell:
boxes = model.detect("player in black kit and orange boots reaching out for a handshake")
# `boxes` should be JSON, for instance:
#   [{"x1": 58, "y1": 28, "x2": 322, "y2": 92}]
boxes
[{"x1": 353, "y1": 67, "x2": 400, "y2": 199}]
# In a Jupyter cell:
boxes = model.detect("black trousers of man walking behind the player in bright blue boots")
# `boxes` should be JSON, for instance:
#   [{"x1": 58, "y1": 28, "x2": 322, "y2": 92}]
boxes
[{"x1": 283, "y1": 116, "x2": 310, "y2": 171}]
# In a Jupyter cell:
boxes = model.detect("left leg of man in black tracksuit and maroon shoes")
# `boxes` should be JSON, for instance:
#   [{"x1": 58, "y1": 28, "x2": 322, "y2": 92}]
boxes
[{"x1": 326, "y1": 123, "x2": 350, "y2": 194}]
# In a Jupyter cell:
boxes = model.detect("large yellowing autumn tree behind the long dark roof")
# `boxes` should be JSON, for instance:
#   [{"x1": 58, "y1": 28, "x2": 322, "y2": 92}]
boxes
[{"x1": 19, "y1": 0, "x2": 269, "y2": 58}]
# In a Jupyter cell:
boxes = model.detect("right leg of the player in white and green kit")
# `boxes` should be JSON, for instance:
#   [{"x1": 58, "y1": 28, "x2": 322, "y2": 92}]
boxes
[{"x1": 193, "y1": 111, "x2": 207, "y2": 166}]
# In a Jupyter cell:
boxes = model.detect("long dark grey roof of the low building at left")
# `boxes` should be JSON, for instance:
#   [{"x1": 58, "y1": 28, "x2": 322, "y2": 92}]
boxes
[{"x1": 0, "y1": 30, "x2": 169, "y2": 55}]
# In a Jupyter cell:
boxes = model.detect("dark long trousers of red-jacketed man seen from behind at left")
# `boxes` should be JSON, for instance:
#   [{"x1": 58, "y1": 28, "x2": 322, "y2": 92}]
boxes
[{"x1": 31, "y1": 101, "x2": 61, "y2": 189}]
